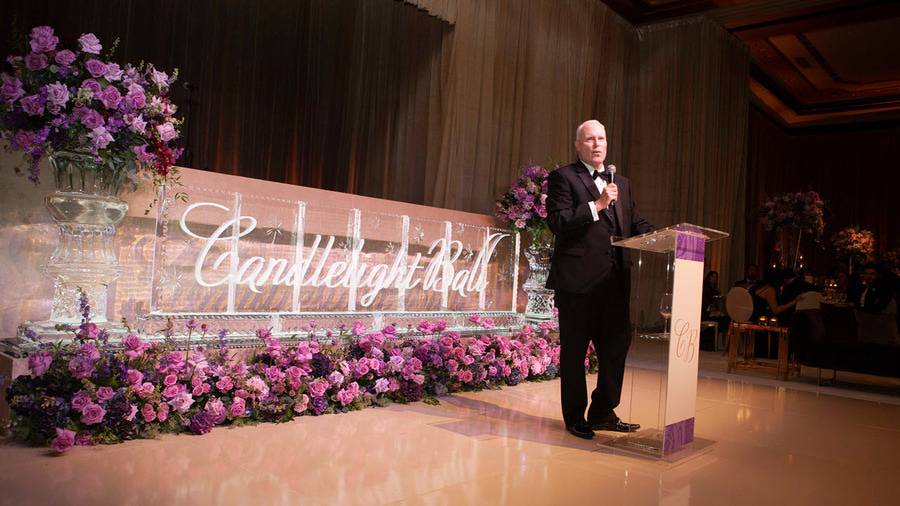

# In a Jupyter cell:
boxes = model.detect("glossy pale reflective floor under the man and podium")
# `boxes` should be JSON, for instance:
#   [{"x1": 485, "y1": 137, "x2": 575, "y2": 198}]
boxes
[{"x1": 0, "y1": 369, "x2": 900, "y2": 506}]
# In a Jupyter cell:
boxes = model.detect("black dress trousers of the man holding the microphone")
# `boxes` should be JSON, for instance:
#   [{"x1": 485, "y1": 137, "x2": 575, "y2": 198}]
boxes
[{"x1": 555, "y1": 275, "x2": 631, "y2": 427}]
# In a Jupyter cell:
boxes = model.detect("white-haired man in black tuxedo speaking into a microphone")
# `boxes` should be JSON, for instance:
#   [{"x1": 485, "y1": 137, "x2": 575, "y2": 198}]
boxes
[{"x1": 547, "y1": 120, "x2": 653, "y2": 439}]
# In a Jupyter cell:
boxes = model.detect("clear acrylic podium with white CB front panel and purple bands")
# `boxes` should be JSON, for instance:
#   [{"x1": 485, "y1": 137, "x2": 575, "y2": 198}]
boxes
[{"x1": 611, "y1": 223, "x2": 728, "y2": 460}]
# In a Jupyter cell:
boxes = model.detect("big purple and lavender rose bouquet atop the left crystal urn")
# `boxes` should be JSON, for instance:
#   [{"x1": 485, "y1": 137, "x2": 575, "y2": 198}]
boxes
[{"x1": 0, "y1": 26, "x2": 182, "y2": 196}]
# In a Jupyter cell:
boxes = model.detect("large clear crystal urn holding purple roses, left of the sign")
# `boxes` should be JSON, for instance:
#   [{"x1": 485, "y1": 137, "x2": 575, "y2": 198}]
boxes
[{"x1": 43, "y1": 151, "x2": 128, "y2": 324}]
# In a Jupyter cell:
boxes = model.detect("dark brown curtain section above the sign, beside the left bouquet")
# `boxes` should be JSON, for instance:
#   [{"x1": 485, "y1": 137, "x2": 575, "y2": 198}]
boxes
[{"x1": 0, "y1": 0, "x2": 450, "y2": 202}]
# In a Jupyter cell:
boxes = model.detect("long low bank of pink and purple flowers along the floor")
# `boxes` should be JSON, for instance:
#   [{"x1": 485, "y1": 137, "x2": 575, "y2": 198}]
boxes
[{"x1": 7, "y1": 294, "x2": 568, "y2": 453}]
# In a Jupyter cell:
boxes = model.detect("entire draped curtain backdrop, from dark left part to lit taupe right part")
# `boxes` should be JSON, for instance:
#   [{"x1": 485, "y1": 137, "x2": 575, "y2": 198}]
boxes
[{"x1": 0, "y1": 0, "x2": 748, "y2": 320}]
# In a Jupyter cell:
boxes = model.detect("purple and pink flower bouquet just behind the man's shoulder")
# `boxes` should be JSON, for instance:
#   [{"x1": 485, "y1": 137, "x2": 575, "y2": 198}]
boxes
[{"x1": 496, "y1": 165, "x2": 549, "y2": 245}]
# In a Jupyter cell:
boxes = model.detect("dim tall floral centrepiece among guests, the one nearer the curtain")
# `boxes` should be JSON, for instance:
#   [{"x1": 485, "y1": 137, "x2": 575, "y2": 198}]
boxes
[{"x1": 760, "y1": 190, "x2": 825, "y2": 240}]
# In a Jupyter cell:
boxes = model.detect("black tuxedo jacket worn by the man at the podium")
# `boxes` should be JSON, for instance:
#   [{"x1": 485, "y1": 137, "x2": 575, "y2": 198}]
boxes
[{"x1": 547, "y1": 161, "x2": 653, "y2": 295}]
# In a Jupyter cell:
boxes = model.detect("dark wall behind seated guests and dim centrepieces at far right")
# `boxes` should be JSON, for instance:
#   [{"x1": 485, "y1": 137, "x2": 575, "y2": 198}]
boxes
[{"x1": 747, "y1": 107, "x2": 900, "y2": 272}]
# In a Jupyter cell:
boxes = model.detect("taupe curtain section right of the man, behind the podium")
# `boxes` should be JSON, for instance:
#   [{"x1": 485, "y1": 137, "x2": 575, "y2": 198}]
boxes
[{"x1": 623, "y1": 17, "x2": 749, "y2": 325}]
